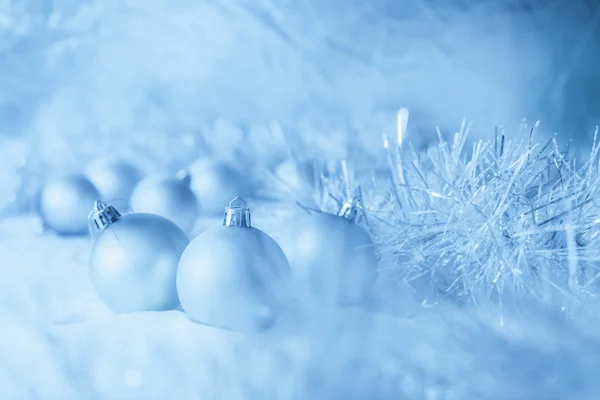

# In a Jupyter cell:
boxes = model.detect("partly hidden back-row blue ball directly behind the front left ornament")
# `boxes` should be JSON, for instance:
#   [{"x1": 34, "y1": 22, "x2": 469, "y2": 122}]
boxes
[{"x1": 130, "y1": 175, "x2": 200, "y2": 232}]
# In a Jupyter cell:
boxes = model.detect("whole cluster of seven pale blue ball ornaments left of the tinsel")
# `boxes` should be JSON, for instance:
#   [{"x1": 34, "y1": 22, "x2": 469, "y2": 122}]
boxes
[{"x1": 39, "y1": 159, "x2": 377, "y2": 333}]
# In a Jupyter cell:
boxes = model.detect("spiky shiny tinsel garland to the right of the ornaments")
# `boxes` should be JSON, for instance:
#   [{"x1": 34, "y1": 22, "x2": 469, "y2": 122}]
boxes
[{"x1": 370, "y1": 123, "x2": 600, "y2": 309}]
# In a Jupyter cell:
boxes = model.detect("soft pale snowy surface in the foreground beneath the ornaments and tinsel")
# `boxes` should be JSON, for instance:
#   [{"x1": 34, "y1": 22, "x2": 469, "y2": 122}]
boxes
[{"x1": 0, "y1": 211, "x2": 600, "y2": 400}]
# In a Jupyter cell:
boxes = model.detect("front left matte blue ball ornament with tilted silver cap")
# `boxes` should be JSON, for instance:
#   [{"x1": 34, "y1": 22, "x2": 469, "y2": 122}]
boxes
[{"x1": 90, "y1": 202, "x2": 189, "y2": 314}]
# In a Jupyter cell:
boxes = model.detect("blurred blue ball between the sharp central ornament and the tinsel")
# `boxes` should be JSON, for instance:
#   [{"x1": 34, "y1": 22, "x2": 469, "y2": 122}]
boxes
[{"x1": 280, "y1": 200, "x2": 377, "y2": 306}]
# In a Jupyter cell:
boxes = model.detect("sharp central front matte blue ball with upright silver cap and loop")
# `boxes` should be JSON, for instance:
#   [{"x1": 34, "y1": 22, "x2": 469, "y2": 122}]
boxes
[{"x1": 177, "y1": 198, "x2": 290, "y2": 333}]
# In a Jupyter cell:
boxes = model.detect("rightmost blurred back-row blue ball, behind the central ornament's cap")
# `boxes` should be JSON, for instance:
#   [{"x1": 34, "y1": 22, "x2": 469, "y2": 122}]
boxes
[{"x1": 188, "y1": 159, "x2": 250, "y2": 216}]
